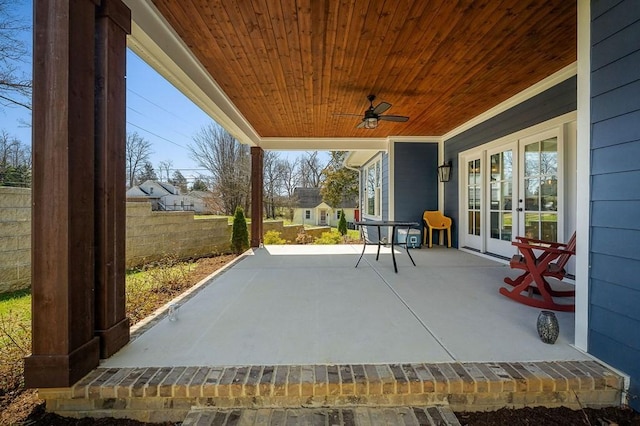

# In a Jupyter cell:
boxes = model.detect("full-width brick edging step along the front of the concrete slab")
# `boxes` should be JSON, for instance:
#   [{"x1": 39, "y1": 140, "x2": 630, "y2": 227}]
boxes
[{"x1": 39, "y1": 361, "x2": 624, "y2": 422}]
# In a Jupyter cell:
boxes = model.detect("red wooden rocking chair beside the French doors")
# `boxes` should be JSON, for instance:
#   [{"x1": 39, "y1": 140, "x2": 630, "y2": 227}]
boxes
[{"x1": 500, "y1": 232, "x2": 576, "y2": 312}]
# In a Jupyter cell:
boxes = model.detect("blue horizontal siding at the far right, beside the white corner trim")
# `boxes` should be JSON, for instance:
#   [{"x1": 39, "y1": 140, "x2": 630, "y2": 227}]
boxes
[{"x1": 589, "y1": 0, "x2": 640, "y2": 410}]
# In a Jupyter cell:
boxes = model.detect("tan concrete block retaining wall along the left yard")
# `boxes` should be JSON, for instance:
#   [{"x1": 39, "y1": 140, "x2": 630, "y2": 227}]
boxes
[{"x1": 0, "y1": 187, "x2": 328, "y2": 293}]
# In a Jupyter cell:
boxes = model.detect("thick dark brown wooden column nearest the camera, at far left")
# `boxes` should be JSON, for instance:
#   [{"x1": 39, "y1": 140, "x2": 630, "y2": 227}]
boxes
[{"x1": 25, "y1": 0, "x2": 100, "y2": 387}]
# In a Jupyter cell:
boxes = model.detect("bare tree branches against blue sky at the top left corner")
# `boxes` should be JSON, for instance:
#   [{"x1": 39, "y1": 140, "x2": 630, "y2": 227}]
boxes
[{"x1": 0, "y1": 0, "x2": 31, "y2": 109}]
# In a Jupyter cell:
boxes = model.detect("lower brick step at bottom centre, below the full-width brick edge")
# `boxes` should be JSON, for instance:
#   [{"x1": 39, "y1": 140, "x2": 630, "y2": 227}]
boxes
[{"x1": 182, "y1": 407, "x2": 460, "y2": 426}]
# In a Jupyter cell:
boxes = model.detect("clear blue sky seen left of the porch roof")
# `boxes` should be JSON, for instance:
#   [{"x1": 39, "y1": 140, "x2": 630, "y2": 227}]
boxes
[{"x1": 0, "y1": 0, "x2": 322, "y2": 185}]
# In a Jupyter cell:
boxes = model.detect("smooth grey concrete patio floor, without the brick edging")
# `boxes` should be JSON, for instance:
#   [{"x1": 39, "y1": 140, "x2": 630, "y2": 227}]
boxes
[{"x1": 101, "y1": 245, "x2": 589, "y2": 368}]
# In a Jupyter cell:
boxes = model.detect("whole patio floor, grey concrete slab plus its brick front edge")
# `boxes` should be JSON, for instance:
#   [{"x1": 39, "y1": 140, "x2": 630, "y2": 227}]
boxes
[{"x1": 39, "y1": 245, "x2": 623, "y2": 425}]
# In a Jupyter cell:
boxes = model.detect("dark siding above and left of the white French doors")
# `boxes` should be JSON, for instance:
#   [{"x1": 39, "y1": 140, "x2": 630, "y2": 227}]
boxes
[{"x1": 444, "y1": 77, "x2": 577, "y2": 247}]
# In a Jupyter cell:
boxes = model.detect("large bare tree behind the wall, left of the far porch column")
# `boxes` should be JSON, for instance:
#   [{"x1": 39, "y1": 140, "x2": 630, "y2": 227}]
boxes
[{"x1": 189, "y1": 124, "x2": 251, "y2": 215}]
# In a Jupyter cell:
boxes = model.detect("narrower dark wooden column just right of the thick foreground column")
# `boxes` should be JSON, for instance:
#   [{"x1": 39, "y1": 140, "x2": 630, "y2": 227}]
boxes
[{"x1": 95, "y1": 0, "x2": 131, "y2": 358}]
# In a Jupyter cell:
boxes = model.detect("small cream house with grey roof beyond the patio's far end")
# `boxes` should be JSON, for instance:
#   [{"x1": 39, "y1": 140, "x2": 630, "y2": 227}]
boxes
[{"x1": 293, "y1": 188, "x2": 357, "y2": 227}]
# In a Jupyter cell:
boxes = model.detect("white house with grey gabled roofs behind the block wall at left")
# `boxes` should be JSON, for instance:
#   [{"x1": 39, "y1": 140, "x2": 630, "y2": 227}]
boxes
[{"x1": 127, "y1": 180, "x2": 211, "y2": 213}]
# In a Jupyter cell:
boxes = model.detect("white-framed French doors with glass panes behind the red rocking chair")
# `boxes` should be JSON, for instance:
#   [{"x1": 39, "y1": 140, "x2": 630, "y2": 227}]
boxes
[{"x1": 460, "y1": 130, "x2": 562, "y2": 257}]
